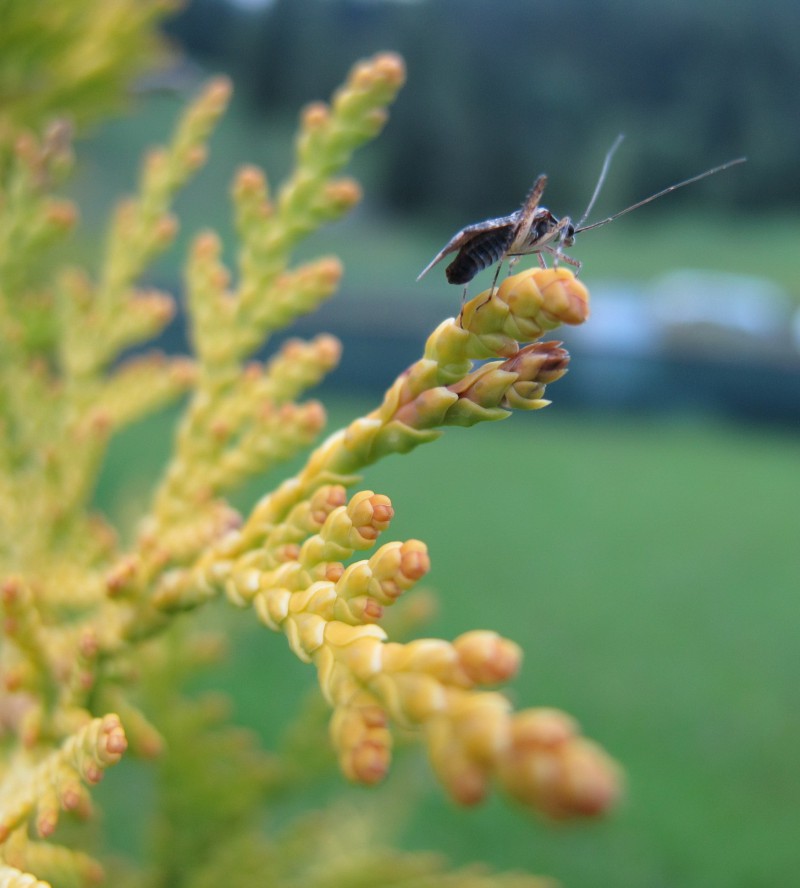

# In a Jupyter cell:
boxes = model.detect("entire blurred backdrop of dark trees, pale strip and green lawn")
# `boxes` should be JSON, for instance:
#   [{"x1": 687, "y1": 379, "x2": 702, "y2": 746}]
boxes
[{"x1": 83, "y1": 0, "x2": 800, "y2": 888}]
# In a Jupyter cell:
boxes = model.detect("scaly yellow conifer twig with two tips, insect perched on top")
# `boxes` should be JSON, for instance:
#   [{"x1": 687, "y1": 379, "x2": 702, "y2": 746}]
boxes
[{"x1": 209, "y1": 268, "x2": 588, "y2": 548}]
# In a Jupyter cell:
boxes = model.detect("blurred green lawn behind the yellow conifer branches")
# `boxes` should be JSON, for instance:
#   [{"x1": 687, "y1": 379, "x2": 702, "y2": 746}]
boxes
[{"x1": 95, "y1": 398, "x2": 800, "y2": 888}]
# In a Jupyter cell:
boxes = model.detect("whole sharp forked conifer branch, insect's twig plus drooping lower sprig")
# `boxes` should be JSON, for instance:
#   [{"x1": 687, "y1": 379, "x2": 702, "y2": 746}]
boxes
[{"x1": 153, "y1": 269, "x2": 619, "y2": 817}]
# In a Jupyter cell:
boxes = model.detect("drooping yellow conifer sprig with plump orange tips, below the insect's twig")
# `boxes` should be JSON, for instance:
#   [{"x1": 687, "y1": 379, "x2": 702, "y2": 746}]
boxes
[{"x1": 158, "y1": 486, "x2": 619, "y2": 817}]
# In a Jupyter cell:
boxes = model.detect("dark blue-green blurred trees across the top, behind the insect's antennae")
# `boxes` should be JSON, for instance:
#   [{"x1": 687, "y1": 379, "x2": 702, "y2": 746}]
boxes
[{"x1": 168, "y1": 0, "x2": 800, "y2": 220}]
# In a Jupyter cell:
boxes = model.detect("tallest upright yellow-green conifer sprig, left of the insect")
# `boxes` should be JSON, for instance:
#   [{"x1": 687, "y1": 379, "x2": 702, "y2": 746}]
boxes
[{"x1": 143, "y1": 55, "x2": 404, "y2": 560}]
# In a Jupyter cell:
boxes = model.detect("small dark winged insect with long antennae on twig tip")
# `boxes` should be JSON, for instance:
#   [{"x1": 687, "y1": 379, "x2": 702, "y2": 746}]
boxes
[{"x1": 417, "y1": 135, "x2": 747, "y2": 298}]
